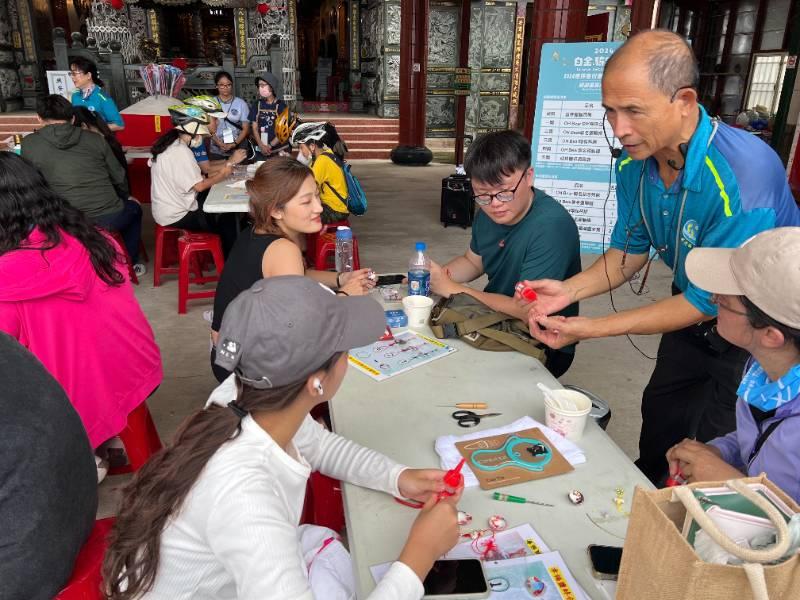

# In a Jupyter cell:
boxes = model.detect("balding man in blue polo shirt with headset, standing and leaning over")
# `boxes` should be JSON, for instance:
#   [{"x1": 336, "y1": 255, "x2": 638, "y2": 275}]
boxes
[{"x1": 520, "y1": 30, "x2": 800, "y2": 485}]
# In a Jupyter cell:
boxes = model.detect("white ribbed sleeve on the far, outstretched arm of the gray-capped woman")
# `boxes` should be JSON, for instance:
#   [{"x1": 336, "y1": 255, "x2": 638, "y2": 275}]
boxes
[{"x1": 294, "y1": 416, "x2": 408, "y2": 496}]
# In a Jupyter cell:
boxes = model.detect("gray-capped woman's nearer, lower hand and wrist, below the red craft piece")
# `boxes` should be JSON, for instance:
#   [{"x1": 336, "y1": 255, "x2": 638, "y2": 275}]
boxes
[{"x1": 398, "y1": 488, "x2": 463, "y2": 581}]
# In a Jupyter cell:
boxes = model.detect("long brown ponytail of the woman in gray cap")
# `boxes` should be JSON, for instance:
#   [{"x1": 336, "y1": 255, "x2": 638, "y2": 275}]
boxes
[{"x1": 103, "y1": 378, "x2": 306, "y2": 600}]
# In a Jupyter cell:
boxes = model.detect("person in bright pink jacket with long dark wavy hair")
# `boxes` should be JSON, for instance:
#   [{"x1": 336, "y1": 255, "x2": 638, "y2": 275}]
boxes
[{"x1": 0, "y1": 152, "x2": 163, "y2": 474}]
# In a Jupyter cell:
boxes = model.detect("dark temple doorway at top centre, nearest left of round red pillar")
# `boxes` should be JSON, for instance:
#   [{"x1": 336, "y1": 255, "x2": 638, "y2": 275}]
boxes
[{"x1": 297, "y1": 0, "x2": 349, "y2": 110}]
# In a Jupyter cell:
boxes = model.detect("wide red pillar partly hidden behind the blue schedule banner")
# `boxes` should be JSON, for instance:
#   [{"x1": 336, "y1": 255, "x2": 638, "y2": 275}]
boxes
[{"x1": 523, "y1": 0, "x2": 589, "y2": 139}]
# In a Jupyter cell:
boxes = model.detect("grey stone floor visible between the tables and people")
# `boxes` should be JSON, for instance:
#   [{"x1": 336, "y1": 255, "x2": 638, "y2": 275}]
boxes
[{"x1": 98, "y1": 161, "x2": 671, "y2": 516}]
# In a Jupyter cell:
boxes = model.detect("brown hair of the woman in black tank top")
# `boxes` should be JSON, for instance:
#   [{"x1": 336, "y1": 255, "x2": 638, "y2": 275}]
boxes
[{"x1": 245, "y1": 156, "x2": 314, "y2": 235}]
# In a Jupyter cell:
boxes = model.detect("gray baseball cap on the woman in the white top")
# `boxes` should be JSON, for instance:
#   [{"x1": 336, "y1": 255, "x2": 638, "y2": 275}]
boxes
[{"x1": 216, "y1": 275, "x2": 386, "y2": 389}]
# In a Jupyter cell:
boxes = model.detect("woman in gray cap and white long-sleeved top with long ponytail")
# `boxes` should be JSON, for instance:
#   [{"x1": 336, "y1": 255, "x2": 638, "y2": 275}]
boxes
[{"x1": 103, "y1": 275, "x2": 461, "y2": 600}]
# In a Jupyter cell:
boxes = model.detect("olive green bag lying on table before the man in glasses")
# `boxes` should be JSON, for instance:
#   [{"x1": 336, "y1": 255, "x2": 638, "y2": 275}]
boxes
[{"x1": 431, "y1": 294, "x2": 546, "y2": 364}]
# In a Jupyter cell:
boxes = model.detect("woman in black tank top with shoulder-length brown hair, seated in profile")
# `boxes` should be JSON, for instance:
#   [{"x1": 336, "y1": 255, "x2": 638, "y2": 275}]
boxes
[{"x1": 211, "y1": 157, "x2": 375, "y2": 382}]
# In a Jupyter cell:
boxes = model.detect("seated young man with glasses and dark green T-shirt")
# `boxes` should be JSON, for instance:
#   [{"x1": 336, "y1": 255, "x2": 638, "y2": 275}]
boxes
[{"x1": 431, "y1": 131, "x2": 581, "y2": 377}]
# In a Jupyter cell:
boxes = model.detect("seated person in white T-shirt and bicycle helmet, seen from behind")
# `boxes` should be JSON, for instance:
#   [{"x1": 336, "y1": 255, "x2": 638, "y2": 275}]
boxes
[{"x1": 149, "y1": 104, "x2": 237, "y2": 257}]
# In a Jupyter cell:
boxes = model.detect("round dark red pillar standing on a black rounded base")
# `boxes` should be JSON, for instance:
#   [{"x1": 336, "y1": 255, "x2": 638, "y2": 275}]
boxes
[{"x1": 391, "y1": 0, "x2": 433, "y2": 165}]
